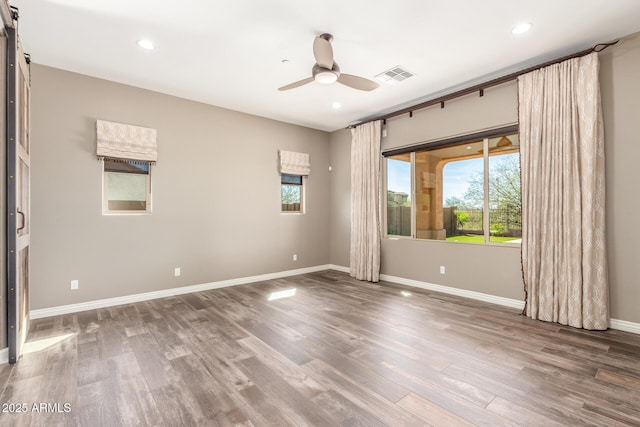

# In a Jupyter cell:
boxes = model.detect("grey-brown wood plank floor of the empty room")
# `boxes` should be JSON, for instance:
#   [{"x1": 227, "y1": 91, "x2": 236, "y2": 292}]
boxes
[{"x1": 0, "y1": 271, "x2": 640, "y2": 427}]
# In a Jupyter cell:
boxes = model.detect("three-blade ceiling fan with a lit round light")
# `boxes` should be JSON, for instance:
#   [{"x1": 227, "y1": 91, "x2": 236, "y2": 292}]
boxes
[{"x1": 278, "y1": 33, "x2": 379, "y2": 91}]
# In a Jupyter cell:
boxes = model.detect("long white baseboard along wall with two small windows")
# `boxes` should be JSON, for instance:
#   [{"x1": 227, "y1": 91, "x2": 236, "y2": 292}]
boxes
[{"x1": 28, "y1": 264, "x2": 331, "y2": 320}]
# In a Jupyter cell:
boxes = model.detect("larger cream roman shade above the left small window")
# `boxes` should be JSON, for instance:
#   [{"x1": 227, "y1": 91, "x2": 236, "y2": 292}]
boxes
[{"x1": 96, "y1": 120, "x2": 158, "y2": 163}]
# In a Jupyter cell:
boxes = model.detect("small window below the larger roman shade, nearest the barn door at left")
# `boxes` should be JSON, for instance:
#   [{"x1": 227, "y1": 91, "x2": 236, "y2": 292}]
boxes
[{"x1": 102, "y1": 159, "x2": 151, "y2": 214}]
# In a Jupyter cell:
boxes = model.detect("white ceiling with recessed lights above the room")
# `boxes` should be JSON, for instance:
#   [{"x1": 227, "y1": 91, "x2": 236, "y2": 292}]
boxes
[{"x1": 11, "y1": 0, "x2": 640, "y2": 131}]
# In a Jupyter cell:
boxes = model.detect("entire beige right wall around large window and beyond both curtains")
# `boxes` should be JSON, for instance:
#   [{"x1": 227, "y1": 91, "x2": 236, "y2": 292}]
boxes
[{"x1": 331, "y1": 36, "x2": 640, "y2": 322}]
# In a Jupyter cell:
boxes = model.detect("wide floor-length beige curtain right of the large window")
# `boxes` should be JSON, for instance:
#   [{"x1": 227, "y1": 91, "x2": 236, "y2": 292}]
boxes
[{"x1": 518, "y1": 53, "x2": 609, "y2": 330}]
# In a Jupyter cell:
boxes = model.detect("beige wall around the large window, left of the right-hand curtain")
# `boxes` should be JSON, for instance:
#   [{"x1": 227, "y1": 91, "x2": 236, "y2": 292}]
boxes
[{"x1": 331, "y1": 83, "x2": 524, "y2": 299}]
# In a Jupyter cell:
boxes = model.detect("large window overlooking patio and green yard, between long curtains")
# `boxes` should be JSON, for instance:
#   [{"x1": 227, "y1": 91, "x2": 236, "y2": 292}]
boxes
[{"x1": 386, "y1": 133, "x2": 522, "y2": 244}]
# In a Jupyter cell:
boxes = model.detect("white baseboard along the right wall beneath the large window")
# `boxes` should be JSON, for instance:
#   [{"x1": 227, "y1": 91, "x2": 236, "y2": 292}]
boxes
[{"x1": 330, "y1": 264, "x2": 640, "y2": 334}]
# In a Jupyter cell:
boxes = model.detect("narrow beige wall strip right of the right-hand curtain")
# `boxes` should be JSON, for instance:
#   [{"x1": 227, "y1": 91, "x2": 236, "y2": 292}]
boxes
[{"x1": 600, "y1": 34, "x2": 640, "y2": 323}]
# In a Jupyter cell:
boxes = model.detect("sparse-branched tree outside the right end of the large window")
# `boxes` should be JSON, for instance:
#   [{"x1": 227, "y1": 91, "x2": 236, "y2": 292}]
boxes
[{"x1": 462, "y1": 153, "x2": 522, "y2": 211}]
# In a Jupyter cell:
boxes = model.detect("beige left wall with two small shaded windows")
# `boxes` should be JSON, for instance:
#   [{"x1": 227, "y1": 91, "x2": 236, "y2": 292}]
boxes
[{"x1": 31, "y1": 65, "x2": 330, "y2": 310}]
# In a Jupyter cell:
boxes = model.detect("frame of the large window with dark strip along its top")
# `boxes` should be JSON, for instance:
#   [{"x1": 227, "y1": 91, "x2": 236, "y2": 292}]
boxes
[{"x1": 380, "y1": 124, "x2": 521, "y2": 248}]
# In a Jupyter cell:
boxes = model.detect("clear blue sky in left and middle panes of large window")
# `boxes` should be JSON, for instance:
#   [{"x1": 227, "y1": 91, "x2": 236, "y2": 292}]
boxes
[{"x1": 387, "y1": 158, "x2": 483, "y2": 201}]
